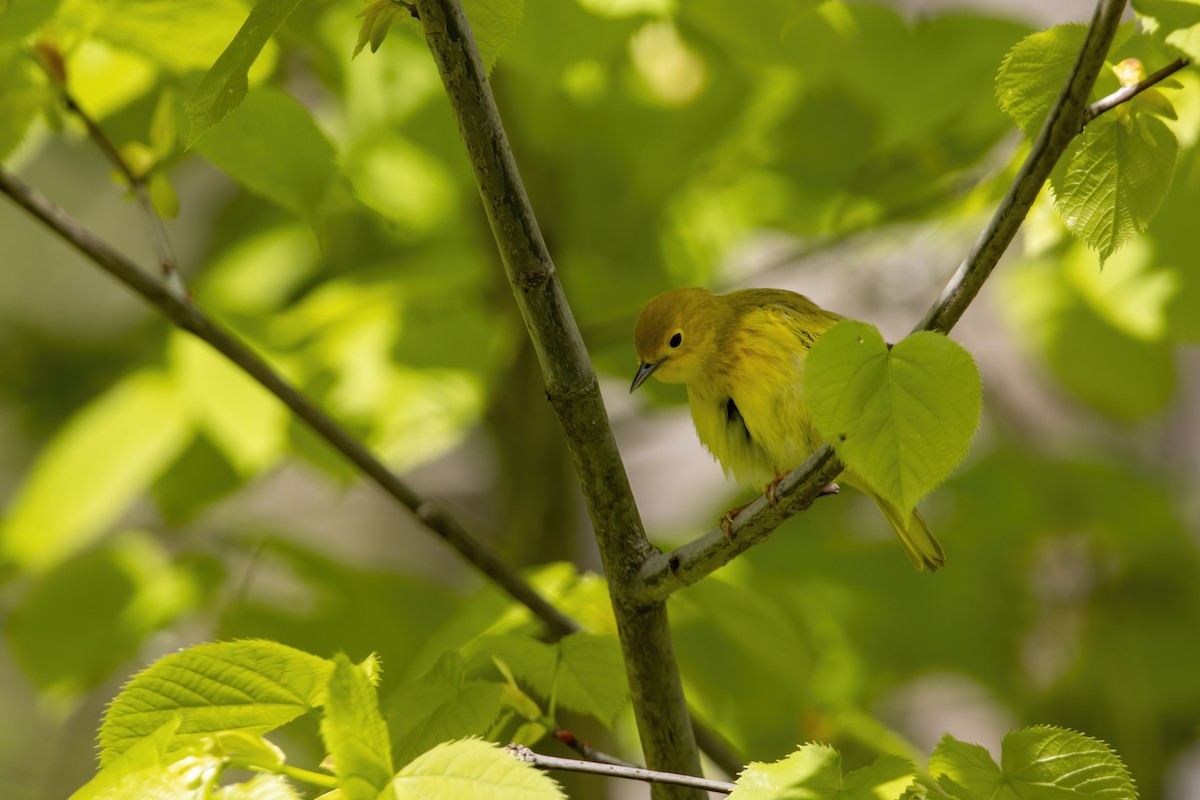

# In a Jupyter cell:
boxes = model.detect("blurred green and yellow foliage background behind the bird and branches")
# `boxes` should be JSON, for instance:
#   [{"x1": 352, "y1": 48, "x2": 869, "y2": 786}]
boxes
[{"x1": 0, "y1": 0, "x2": 1200, "y2": 800}]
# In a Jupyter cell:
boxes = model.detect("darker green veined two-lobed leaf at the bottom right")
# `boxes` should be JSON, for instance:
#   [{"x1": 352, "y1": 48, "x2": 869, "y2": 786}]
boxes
[{"x1": 929, "y1": 726, "x2": 1138, "y2": 800}]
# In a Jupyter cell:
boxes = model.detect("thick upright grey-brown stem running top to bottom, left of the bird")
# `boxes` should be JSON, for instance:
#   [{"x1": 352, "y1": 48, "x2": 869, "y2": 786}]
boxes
[{"x1": 415, "y1": 0, "x2": 700, "y2": 798}]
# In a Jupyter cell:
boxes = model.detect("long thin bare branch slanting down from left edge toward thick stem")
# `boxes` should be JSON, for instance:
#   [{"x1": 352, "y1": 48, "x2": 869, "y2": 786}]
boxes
[{"x1": 0, "y1": 169, "x2": 580, "y2": 637}]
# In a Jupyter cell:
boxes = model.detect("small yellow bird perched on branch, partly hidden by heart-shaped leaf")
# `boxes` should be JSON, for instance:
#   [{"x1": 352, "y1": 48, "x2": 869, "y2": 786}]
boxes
[{"x1": 629, "y1": 289, "x2": 946, "y2": 571}]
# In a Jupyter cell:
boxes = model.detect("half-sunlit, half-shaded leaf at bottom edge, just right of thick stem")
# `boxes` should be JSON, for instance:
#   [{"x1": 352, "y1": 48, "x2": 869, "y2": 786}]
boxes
[{"x1": 730, "y1": 745, "x2": 917, "y2": 800}]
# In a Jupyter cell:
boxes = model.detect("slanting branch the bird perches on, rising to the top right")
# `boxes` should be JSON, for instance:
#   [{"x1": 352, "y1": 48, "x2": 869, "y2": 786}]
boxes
[{"x1": 632, "y1": 0, "x2": 1128, "y2": 603}]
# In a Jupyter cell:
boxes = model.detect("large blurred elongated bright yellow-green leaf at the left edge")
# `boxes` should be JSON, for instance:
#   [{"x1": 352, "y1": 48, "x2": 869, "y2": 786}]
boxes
[{"x1": 0, "y1": 371, "x2": 192, "y2": 571}]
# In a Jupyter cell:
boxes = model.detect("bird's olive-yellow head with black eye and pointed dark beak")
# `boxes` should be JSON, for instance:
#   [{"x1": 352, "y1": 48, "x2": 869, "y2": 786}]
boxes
[{"x1": 629, "y1": 289, "x2": 721, "y2": 391}]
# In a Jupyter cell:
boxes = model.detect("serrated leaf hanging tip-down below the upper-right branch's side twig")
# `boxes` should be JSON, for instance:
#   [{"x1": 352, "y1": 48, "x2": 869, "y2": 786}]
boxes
[{"x1": 1050, "y1": 109, "x2": 1178, "y2": 264}]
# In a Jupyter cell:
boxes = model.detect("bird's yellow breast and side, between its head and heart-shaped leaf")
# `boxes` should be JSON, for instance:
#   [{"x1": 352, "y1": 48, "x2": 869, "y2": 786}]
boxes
[{"x1": 688, "y1": 308, "x2": 820, "y2": 487}]
